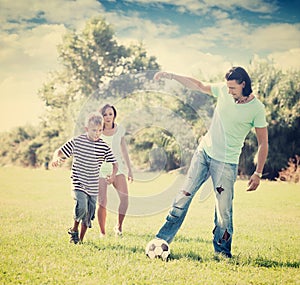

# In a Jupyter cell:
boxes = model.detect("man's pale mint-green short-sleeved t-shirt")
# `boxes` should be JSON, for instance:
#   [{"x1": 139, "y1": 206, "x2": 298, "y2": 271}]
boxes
[{"x1": 199, "y1": 83, "x2": 267, "y2": 164}]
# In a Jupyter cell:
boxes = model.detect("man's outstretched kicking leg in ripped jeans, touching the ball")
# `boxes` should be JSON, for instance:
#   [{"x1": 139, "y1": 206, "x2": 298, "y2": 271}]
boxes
[{"x1": 156, "y1": 149, "x2": 210, "y2": 243}]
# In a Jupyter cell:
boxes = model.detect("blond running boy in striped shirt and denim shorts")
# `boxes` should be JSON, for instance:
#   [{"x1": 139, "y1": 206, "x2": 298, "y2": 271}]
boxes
[{"x1": 52, "y1": 114, "x2": 118, "y2": 244}]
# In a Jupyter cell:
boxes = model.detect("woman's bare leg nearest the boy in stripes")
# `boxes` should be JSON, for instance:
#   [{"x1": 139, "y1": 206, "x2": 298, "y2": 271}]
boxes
[{"x1": 97, "y1": 178, "x2": 107, "y2": 236}]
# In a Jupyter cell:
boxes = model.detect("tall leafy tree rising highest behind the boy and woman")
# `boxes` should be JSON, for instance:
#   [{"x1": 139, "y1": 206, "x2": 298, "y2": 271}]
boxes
[{"x1": 39, "y1": 17, "x2": 159, "y2": 160}]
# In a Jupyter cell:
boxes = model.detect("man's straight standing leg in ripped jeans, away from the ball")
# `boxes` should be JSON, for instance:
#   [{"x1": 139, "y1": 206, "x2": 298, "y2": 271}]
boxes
[{"x1": 210, "y1": 161, "x2": 237, "y2": 257}]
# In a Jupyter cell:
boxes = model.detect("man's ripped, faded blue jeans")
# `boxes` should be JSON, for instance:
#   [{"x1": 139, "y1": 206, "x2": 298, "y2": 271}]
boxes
[{"x1": 156, "y1": 149, "x2": 238, "y2": 257}]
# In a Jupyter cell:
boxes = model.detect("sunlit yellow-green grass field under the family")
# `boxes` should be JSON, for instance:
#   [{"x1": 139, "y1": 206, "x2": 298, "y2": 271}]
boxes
[{"x1": 0, "y1": 168, "x2": 300, "y2": 285}]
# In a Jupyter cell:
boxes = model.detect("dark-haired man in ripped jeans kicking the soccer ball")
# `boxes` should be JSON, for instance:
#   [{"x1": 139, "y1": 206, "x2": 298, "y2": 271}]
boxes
[{"x1": 154, "y1": 67, "x2": 268, "y2": 258}]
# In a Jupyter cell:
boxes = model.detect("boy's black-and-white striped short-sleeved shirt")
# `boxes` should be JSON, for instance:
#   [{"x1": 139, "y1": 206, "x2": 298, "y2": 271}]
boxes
[{"x1": 60, "y1": 134, "x2": 116, "y2": 196}]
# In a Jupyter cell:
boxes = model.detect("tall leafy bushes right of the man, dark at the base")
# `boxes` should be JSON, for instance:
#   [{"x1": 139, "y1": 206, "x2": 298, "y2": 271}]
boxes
[{"x1": 240, "y1": 59, "x2": 300, "y2": 179}]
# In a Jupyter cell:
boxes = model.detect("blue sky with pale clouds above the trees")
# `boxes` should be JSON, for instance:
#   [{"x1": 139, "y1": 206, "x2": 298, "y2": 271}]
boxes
[{"x1": 0, "y1": 0, "x2": 300, "y2": 132}]
